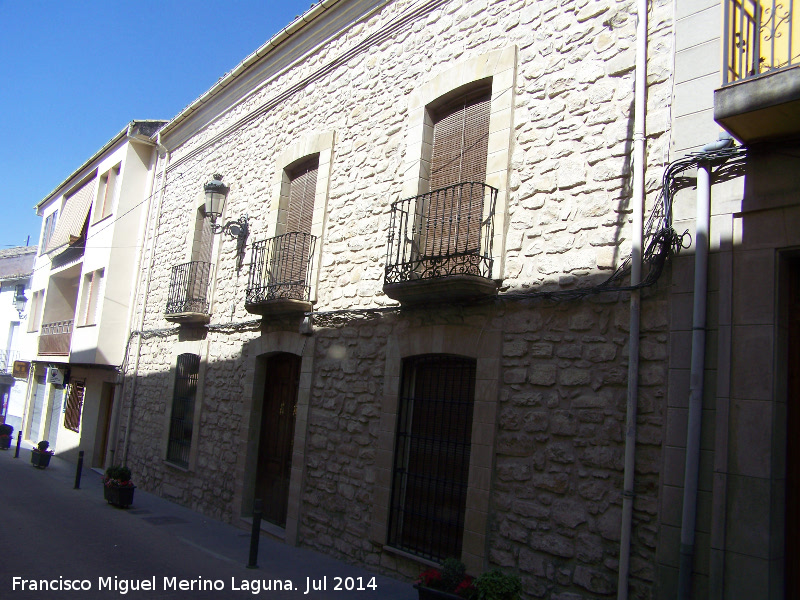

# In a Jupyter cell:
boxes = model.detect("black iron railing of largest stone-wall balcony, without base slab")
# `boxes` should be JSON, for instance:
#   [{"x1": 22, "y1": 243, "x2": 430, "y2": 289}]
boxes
[{"x1": 385, "y1": 183, "x2": 497, "y2": 284}]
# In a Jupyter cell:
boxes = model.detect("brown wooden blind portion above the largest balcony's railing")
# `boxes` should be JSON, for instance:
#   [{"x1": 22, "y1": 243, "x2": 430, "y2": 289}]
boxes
[{"x1": 430, "y1": 87, "x2": 491, "y2": 190}]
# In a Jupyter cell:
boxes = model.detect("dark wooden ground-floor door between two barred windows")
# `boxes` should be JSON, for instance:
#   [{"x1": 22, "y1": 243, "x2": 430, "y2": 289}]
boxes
[{"x1": 255, "y1": 354, "x2": 301, "y2": 527}]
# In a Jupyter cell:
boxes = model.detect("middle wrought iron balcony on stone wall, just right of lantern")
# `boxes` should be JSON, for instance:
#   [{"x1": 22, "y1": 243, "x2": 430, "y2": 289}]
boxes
[{"x1": 245, "y1": 232, "x2": 317, "y2": 315}]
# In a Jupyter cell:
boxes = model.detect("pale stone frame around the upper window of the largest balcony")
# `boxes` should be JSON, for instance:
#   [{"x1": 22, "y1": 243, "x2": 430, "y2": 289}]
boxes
[{"x1": 402, "y1": 45, "x2": 518, "y2": 280}]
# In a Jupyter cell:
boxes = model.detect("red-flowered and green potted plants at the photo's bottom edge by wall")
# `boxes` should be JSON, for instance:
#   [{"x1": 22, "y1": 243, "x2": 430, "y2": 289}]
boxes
[{"x1": 414, "y1": 558, "x2": 522, "y2": 600}]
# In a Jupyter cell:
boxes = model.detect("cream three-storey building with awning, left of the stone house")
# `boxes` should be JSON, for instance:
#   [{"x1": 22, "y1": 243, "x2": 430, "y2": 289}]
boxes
[{"x1": 23, "y1": 121, "x2": 163, "y2": 468}]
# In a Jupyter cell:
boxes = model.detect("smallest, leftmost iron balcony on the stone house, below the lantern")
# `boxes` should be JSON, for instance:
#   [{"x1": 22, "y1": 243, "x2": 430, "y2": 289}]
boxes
[{"x1": 164, "y1": 261, "x2": 211, "y2": 323}]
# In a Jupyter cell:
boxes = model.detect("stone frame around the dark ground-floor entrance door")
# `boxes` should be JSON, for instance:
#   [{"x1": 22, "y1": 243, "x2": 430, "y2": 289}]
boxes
[{"x1": 233, "y1": 331, "x2": 314, "y2": 546}]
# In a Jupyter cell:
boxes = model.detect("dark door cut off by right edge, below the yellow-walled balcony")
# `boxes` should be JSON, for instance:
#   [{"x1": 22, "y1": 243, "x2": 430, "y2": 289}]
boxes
[{"x1": 785, "y1": 259, "x2": 800, "y2": 598}]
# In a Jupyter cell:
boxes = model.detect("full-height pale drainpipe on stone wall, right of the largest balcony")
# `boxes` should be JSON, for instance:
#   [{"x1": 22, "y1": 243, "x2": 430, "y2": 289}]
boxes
[{"x1": 617, "y1": 0, "x2": 647, "y2": 600}]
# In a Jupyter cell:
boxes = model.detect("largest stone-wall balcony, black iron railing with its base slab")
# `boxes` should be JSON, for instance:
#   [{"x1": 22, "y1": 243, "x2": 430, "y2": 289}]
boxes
[{"x1": 383, "y1": 182, "x2": 497, "y2": 304}]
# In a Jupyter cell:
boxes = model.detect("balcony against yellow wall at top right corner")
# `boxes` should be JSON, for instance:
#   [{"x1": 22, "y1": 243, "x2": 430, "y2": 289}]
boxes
[{"x1": 714, "y1": 0, "x2": 800, "y2": 143}]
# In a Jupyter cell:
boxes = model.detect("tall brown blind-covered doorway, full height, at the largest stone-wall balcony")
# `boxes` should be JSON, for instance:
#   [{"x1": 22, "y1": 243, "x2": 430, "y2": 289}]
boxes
[{"x1": 417, "y1": 87, "x2": 491, "y2": 274}]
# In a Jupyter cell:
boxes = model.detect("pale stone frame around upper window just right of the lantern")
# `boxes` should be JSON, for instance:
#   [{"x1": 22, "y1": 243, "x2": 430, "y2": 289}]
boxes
[{"x1": 267, "y1": 131, "x2": 335, "y2": 304}]
